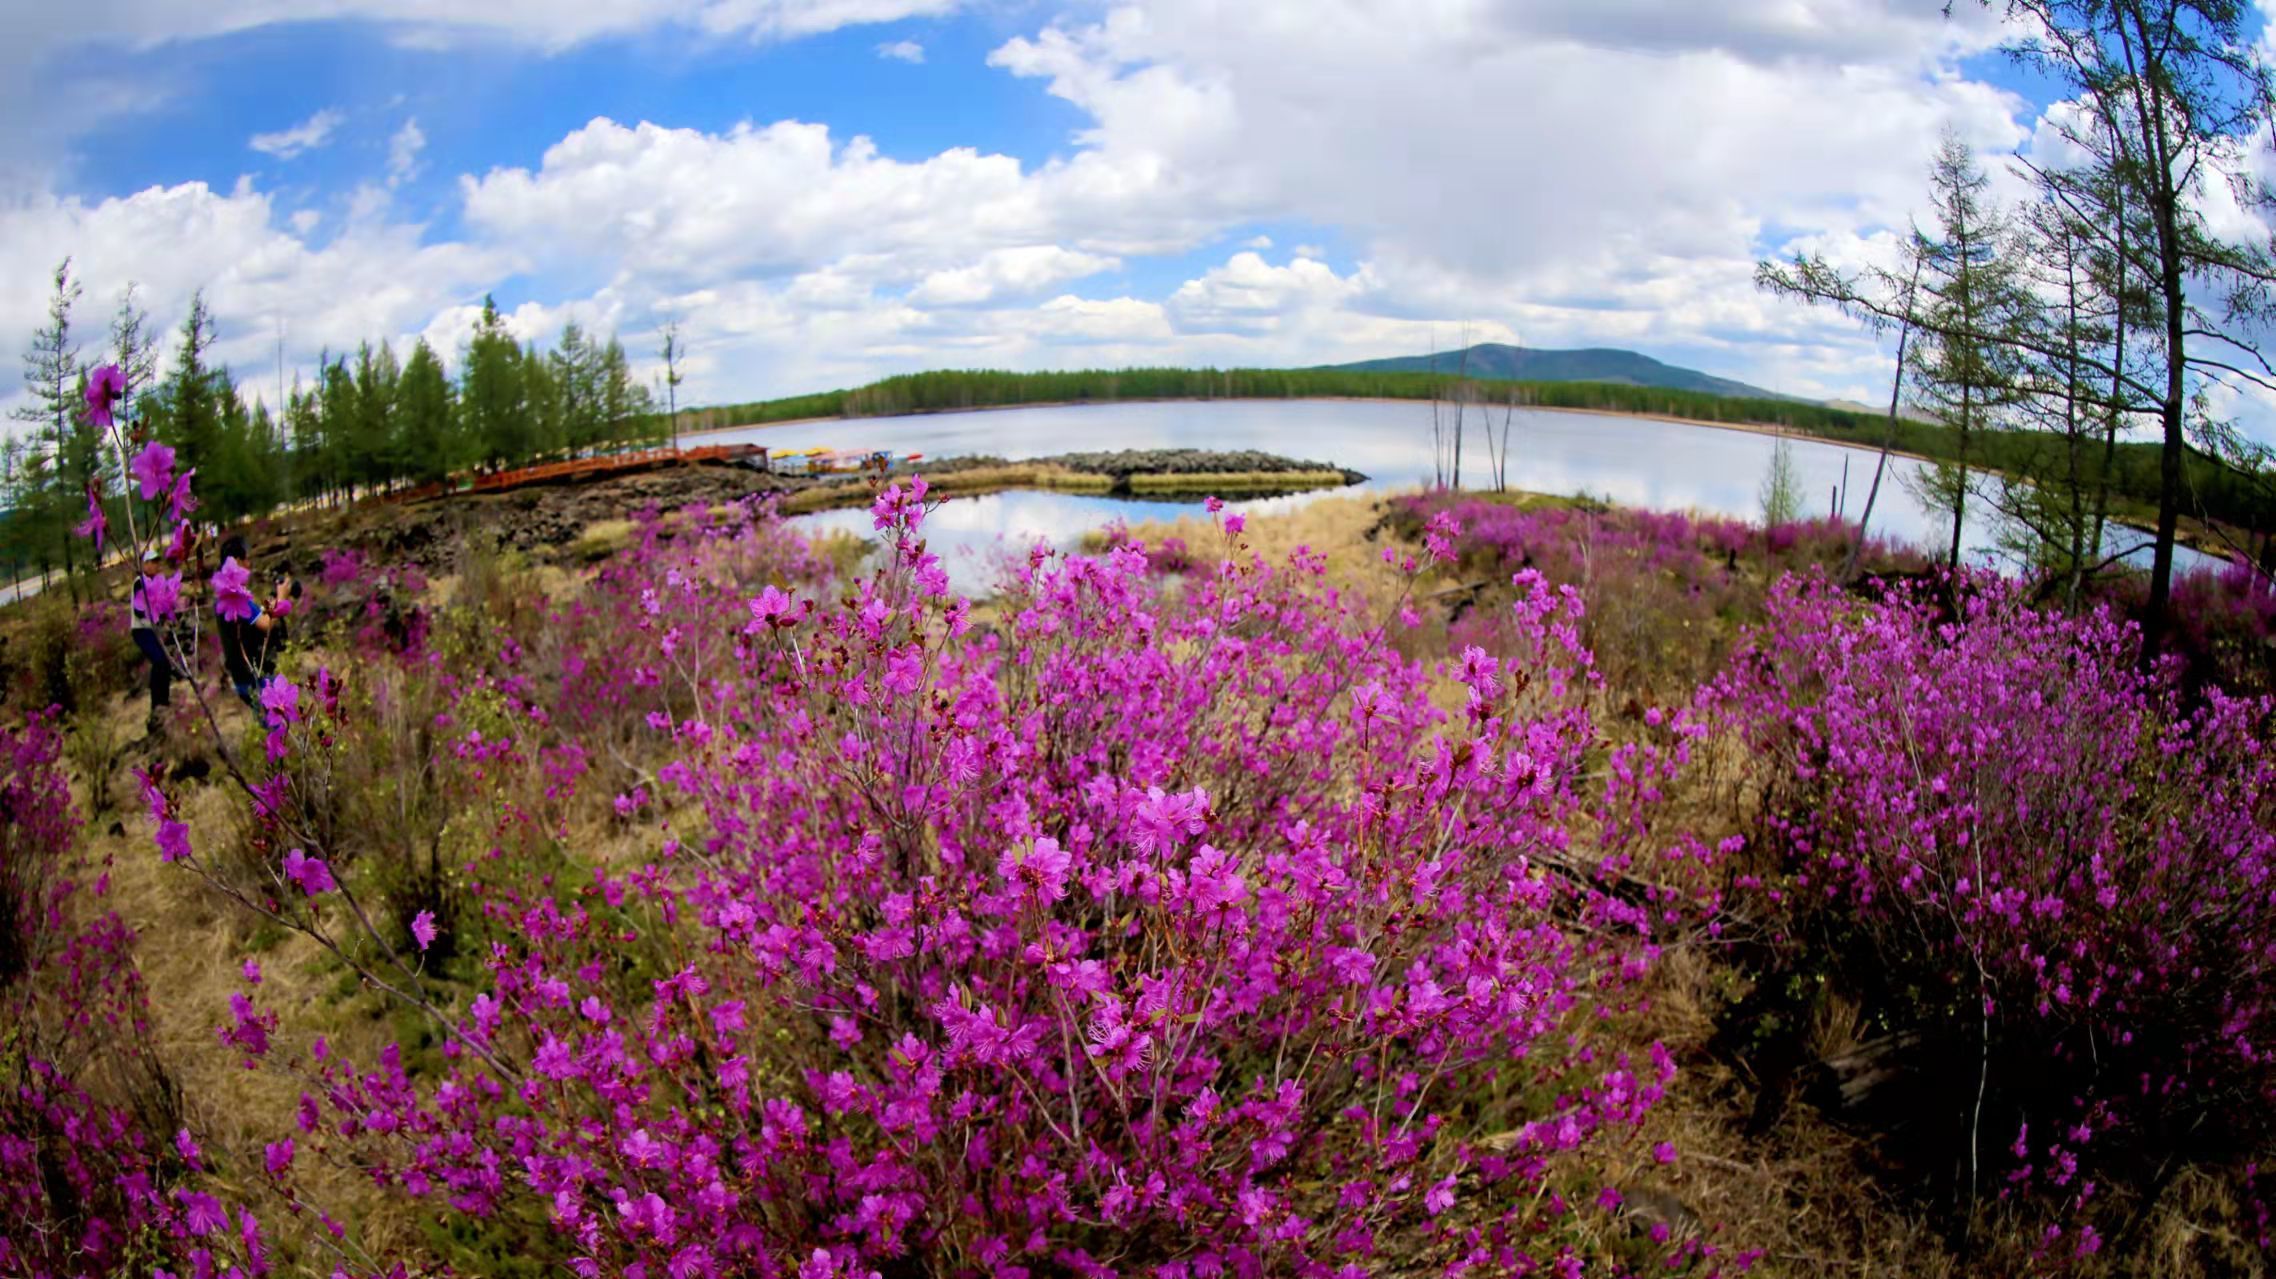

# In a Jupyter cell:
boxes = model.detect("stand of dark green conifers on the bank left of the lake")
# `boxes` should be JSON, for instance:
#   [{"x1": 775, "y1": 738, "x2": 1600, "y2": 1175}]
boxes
[{"x1": 0, "y1": 273, "x2": 671, "y2": 589}]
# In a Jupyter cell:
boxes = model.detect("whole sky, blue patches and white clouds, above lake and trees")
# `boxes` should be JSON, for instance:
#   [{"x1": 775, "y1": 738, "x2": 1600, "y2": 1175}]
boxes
[{"x1": 0, "y1": 0, "x2": 2257, "y2": 427}]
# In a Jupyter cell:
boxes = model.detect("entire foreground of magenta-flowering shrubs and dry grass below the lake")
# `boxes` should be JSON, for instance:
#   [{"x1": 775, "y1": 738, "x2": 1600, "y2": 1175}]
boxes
[{"x1": 17, "y1": 361, "x2": 2276, "y2": 1279}]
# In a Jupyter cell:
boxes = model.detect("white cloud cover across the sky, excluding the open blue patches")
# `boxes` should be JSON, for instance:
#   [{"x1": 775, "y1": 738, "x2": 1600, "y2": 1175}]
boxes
[{"x1": 0, "y1": 0, "x2": 2130, "y2": 421}]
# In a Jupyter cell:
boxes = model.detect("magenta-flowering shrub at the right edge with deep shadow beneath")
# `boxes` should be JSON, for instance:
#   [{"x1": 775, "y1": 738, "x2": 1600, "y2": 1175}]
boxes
[{"x1": 1702, "y1": 578, "x2": 2276, "y2": 1252}]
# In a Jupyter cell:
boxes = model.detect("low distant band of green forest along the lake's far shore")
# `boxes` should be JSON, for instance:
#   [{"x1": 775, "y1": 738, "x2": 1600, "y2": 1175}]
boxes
[{"x1": 683, "y1": 369, "x2": 2276, "y2": 528}]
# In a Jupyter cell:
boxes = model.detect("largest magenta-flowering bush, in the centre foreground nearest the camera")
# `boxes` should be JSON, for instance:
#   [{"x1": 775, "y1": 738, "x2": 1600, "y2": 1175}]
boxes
[{"x1": 152, "y1": 480, "x2": 1714, "y2": 1277}]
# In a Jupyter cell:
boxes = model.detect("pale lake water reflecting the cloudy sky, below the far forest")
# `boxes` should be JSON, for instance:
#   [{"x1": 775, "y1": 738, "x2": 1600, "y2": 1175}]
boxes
[{"x1": 703, "y1": 401, "x2": 2194, "y2": 589}]
